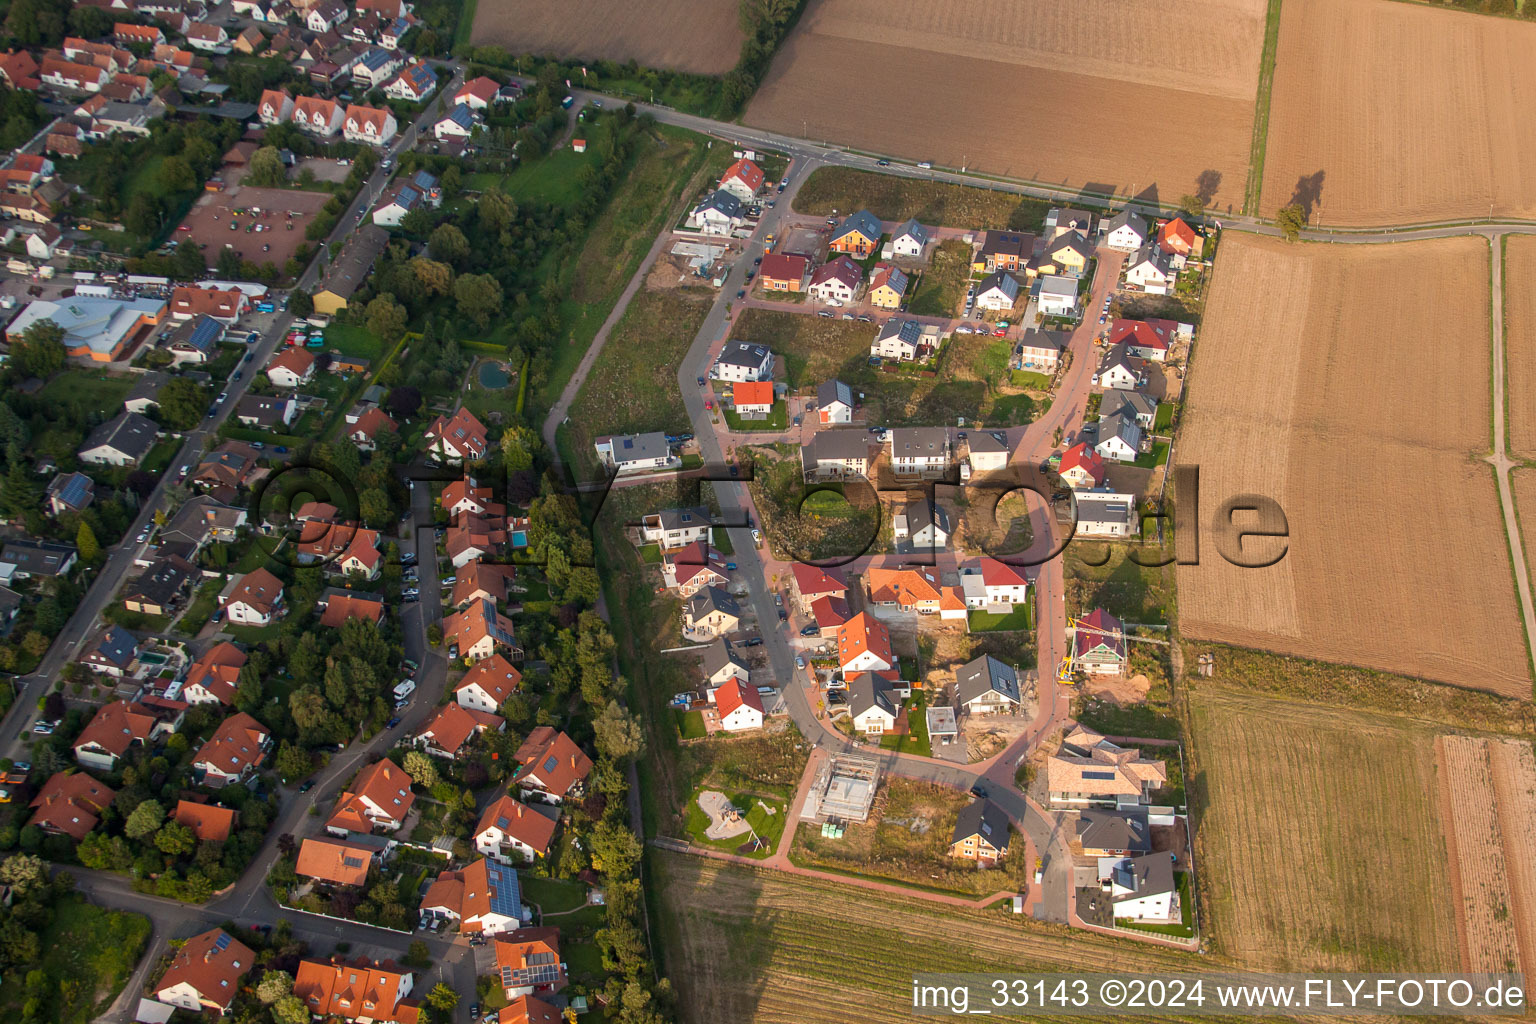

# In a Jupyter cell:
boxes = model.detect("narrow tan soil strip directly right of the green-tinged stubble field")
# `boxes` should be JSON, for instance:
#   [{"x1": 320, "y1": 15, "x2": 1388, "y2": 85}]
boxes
[{"x1": 1435, "y1": 735, "x2": 1531, "y2": 972}]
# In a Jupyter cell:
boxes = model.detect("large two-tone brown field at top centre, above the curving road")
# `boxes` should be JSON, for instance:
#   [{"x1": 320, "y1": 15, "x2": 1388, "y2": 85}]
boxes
[{"x1": 743, "y1": 0, "x2": 1267, "y2": 209}]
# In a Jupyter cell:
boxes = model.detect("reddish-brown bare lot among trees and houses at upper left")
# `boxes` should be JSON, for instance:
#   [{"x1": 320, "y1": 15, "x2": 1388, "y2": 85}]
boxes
[{"x1": 175, "y1": 186, "x2": 330, "y2": 270}]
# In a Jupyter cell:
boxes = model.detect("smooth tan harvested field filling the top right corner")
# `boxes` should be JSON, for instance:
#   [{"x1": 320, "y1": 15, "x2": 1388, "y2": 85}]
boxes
[{"x1": 1261, "y1": 0, "x2": 1536, "y2": 226}]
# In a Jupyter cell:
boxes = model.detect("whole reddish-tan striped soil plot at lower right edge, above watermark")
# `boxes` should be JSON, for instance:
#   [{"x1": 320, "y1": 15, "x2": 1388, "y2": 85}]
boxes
[{"x1": 1435, "y1": 735, "x2": 1536, "y2": 972}]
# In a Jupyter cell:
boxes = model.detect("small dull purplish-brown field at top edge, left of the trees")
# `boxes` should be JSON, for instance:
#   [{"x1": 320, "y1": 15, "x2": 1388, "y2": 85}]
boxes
[{"x1": 470, "y1": 0, "x2": 742, "y2": 75}]
